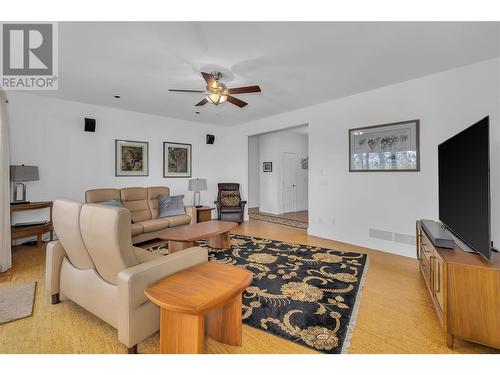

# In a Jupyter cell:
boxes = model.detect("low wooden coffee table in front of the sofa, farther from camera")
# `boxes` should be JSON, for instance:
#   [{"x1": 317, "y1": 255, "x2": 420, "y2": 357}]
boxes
[{"x1": 158, "y1": 220, "x2": 238, "y2": 253}]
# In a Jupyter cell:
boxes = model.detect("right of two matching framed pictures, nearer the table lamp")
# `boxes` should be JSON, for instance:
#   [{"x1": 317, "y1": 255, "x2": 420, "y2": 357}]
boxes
[{"x1": 163, "y1": 142, "x2": 191, "y2": 178}]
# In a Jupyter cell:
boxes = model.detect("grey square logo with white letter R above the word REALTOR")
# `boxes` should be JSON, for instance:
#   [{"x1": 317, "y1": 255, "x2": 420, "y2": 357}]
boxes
[{"x1": 2, "y1": 23, "x2": 54, "y2": 76}]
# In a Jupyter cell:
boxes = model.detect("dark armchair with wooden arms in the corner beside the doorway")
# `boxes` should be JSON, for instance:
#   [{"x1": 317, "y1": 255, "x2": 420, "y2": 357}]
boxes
[{"x1": 214, "y1": 183, "x2": 247, "y2": 224}]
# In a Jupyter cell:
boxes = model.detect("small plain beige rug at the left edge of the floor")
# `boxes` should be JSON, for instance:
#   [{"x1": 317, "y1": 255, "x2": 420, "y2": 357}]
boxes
[{"x1": 0, "y1": 282, "x2": 36, "y2": 324}]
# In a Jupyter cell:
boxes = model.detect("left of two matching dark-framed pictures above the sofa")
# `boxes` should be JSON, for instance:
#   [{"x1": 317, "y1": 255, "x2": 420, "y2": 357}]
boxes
[{"x1": 115, "y1": 139, "x2": 149, "y2": 177}]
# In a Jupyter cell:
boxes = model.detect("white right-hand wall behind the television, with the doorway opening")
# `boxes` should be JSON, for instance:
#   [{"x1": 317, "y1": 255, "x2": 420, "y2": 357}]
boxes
[{"x1": 230, "y1": 58, "x2": 500, "y2": 257}]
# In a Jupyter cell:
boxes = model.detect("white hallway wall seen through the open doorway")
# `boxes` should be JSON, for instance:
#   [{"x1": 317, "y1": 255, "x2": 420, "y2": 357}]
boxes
[{"x1": 259, "y1": 131, "x2": 308, "y2": 214}]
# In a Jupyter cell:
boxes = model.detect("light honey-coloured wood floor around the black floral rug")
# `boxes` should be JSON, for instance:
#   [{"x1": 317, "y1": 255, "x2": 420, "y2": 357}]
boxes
[{"x1": 0, "y1": 220, "x2": 500, "y2": 353}]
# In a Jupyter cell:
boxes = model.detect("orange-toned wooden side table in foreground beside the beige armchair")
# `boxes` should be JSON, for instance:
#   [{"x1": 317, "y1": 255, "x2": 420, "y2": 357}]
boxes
[{"x1": 144, "y1": 262, "x2": 252, "y2": 354}]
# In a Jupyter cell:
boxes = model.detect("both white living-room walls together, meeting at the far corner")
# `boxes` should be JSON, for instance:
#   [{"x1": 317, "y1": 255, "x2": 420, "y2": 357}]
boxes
[{"x1": 8, "y1": 59, "x2": 500, "y2": 262}]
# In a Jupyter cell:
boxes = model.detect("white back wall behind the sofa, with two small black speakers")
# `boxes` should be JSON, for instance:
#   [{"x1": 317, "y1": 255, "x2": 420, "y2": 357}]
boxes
[{"x1": 8, "y1": 93, "x2": 247, "y2": 226}]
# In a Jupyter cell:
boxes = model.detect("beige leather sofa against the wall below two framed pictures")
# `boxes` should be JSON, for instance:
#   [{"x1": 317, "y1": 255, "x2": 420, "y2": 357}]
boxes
[{"x1": 85, "y1": 186, "x2": 196, "y2": 244}]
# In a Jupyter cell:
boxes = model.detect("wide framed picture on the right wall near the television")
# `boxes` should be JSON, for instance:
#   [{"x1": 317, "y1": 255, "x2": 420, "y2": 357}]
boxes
[{"x1": 349, "y1": 120, "x2": 420, "y2": 172}]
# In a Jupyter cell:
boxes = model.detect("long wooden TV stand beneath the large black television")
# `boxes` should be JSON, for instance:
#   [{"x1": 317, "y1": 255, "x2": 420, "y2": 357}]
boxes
[{"x1": 417, "y1": 221, "x2": 500, "y2": 349}]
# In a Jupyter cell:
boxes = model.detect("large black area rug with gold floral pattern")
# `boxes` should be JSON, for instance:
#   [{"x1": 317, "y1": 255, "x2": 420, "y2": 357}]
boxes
[{"x1": 145, "y1": 235, "x2": 367, "y2": 354}]
